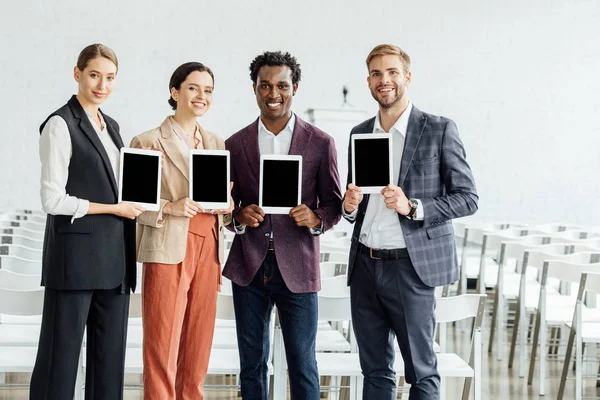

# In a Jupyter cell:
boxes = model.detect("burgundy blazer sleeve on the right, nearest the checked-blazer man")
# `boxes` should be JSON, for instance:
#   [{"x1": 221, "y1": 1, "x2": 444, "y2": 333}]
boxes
[{"x1": 313, "y1": 137, "x2": 342, "y2": 233}]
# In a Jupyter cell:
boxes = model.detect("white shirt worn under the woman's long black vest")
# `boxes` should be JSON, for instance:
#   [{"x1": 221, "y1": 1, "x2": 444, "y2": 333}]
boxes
[{"x1": 39, "y1": 112, "x2": 120, "y2": 222}]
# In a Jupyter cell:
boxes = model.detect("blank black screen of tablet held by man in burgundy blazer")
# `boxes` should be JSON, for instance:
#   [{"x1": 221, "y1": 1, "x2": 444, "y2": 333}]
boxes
[{"x1": 262, "y1": 160, "x2": 300, "y2": 208}]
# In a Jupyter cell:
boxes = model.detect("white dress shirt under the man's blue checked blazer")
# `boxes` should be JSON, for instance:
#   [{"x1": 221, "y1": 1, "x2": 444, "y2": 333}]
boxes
[{"x1": 342, "y1": 103, "x2": 424, "y2": 249}]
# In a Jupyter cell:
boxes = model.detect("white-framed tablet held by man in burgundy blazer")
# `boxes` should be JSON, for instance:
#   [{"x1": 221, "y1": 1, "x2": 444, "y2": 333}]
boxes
[{"x1": 258, "y1": 155, "x2": 302, "y2": 214}]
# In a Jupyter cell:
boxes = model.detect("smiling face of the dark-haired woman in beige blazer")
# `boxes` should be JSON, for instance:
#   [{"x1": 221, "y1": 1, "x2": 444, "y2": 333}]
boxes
[{"x1": 171, "y1": 71, "x2": 214, "y2": 117}]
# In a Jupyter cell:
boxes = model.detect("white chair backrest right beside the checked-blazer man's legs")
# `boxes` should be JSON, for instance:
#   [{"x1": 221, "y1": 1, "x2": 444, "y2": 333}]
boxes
[{"x1": 435, "y1": 294, "x2": 486, "y2": 328}]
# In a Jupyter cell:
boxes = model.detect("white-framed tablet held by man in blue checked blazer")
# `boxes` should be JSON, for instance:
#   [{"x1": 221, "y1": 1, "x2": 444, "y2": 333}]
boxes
[{"x1": 352, "y1": 133, "x2": 394, "y2": 193}]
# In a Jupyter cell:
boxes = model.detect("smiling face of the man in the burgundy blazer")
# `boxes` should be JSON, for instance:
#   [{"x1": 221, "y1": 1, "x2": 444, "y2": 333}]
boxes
[{"x1": 252, "y1": 65, "x2": 298, "y2": 121}]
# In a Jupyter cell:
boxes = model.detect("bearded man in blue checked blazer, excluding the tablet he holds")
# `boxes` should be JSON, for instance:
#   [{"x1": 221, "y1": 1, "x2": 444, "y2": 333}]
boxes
[{"x1": 343, "y1": 44, "x2": 478, "y2": 400}]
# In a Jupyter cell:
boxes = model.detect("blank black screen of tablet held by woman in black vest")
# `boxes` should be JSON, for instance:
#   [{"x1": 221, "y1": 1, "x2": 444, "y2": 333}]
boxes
[{"x1": 121, "y1": 153, "x2": 160, "y2": 204}]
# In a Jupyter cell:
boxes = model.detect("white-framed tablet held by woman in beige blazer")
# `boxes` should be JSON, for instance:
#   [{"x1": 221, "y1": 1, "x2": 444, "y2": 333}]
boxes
[{"x1": 189, "y1": 150, "x2": 230, "y2": 210}]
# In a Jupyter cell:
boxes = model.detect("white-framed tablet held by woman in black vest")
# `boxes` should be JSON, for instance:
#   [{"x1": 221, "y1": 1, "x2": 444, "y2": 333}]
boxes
[{"x1": 119, "y1": 147, "x2": 162, "y2": 211}]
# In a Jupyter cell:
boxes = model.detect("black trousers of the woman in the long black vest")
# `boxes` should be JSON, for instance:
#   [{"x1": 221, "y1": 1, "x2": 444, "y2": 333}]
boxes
[{"x1": 29, "y1": 287, "x2": 129, "y2": 400}]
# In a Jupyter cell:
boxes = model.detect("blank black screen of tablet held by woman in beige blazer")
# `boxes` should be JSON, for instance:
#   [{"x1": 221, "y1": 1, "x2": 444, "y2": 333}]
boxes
[{"x1": 192, "y1": 154, "x2": 229, "y2": 203}]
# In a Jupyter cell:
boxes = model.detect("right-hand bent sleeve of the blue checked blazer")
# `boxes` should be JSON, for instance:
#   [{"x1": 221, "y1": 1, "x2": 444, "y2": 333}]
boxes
[{"x1": 420, "y1": 120, "x2": 479, "y2": 227}]
